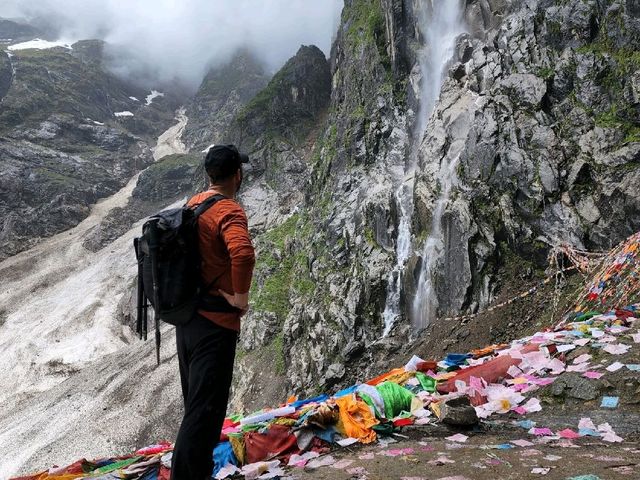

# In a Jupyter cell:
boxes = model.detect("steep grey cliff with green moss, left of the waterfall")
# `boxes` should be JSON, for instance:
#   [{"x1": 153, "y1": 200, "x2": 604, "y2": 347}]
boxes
[{"x1": 234, "y1": 1, "x2": 407, "y2": 407}]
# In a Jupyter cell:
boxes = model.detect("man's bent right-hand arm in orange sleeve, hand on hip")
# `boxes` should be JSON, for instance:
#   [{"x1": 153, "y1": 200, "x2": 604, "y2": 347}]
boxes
[{"x1": 220, "y1": 202, "x2": 255, "y2": 311}]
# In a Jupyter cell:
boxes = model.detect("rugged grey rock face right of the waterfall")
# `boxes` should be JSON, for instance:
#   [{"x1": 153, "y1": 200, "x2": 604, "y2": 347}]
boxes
[{"x1": 415, "y1": 1, "x2": 640, "y2": 314}]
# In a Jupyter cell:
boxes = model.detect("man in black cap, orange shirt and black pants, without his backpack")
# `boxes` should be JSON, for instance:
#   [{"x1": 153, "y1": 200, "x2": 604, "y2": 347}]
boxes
[{"x1": 171, "y1": 145, "x2": 255, "y2": 480}]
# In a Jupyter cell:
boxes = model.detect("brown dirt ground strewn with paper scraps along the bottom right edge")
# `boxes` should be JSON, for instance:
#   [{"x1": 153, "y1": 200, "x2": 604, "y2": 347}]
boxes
[{"x1": 290, "y1": 429, "x2": 640, "y2": 480}]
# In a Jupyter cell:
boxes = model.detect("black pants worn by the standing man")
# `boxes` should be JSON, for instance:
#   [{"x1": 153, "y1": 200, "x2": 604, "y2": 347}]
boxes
[{"x1": 171, "y1": 314, "x2": 238, "y2": 480}]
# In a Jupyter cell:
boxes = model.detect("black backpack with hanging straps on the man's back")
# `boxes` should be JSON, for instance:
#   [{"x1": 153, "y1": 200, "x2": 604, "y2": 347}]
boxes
[{"x1": 133, "y1": 194, "x2": 237, "y2": 364}]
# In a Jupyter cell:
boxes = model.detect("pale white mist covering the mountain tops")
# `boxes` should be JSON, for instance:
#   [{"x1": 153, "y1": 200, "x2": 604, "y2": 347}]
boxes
[{"x1": 0, "y1": 0, "x2": 343, "y2": 88}]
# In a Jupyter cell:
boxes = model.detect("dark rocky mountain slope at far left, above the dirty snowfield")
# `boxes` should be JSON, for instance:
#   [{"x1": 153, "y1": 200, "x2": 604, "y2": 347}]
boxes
[{"x1": 0, "y1": 41, "x2": 177, "y2": 258}]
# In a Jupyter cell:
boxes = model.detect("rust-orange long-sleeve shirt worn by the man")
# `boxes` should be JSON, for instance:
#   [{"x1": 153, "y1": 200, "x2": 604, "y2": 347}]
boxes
[{"x1": 188, "y1": 190, "x2": 255, "y2": 331}]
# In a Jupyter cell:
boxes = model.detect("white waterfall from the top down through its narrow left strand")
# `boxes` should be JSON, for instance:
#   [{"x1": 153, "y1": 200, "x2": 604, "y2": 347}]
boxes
[{"x1": 382, "y1": 0, "x2": 465, "y2": 336}]
